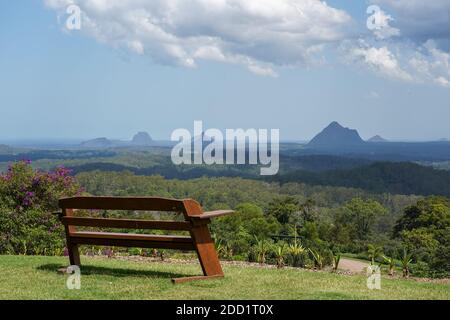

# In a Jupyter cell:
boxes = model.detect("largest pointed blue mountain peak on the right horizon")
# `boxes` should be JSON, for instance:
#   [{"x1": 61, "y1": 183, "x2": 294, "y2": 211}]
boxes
[{"x1": 308, "y1": 121, "x2": 365, "y2": 149}]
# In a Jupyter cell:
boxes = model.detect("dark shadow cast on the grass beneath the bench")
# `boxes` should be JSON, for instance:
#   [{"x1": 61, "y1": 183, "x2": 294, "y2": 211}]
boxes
[{"x1": 36, "y1": 263, "x2": 188, "y2": 279}]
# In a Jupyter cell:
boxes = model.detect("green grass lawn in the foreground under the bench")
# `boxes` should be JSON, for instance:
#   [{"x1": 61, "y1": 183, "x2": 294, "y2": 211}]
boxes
[{"x1": 0, "y1": 256, "x2": 450, "y2": 299}]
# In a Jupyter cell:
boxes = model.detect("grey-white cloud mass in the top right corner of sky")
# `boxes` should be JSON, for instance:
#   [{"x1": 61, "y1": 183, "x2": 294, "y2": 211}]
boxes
[{"x1": 342, "y1": 0, "x2": 450, "y2": 88}]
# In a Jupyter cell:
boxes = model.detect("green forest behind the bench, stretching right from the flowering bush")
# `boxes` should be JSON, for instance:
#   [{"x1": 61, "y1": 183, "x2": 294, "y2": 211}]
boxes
[{"x1": 76, "y1": 171, "x2": 450, "y2": 276}]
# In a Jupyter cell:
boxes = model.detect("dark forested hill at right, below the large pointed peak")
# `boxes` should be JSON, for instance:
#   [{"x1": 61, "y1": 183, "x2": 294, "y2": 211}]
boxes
[{"x1": 270, "y1": 162, "x2": 450, "y2": 197}]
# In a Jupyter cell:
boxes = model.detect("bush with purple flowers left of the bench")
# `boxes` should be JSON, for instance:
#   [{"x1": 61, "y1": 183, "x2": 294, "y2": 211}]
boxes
[{"x1": 0, "y1": 161, "x2": 83, "y2": 254}]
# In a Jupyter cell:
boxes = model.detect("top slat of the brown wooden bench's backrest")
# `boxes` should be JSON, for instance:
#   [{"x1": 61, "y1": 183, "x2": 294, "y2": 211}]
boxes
[{"x1": 59, "y1": 197, "x2": 185, "y2": 213}]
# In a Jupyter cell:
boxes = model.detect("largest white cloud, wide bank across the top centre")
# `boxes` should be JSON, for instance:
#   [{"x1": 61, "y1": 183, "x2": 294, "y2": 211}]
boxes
[{"x1": 45, "y1": 0, "x2": 351, "y2": 76}]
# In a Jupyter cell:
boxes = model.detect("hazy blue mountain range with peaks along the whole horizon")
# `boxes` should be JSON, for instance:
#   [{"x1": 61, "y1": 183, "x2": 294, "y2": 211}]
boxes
[{"x1": 0, "y1": 121, "x2": 450, "y2": 161}]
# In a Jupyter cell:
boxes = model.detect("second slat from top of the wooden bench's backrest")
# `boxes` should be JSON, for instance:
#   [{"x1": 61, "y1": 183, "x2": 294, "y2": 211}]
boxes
[{"x1": 61, "y1": 217, "x2": 192, "y2": 231}]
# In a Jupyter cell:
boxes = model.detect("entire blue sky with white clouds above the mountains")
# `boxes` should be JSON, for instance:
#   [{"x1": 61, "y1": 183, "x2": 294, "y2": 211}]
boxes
[{"x1": 0, "y1": 0, "x2": 450, "y2": 141}]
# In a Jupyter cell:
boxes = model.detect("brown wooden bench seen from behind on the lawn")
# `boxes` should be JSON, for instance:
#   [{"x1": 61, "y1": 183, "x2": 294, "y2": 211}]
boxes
[{"x1": 58, "y1": 197, "x2": 233, "y2": 283}]
